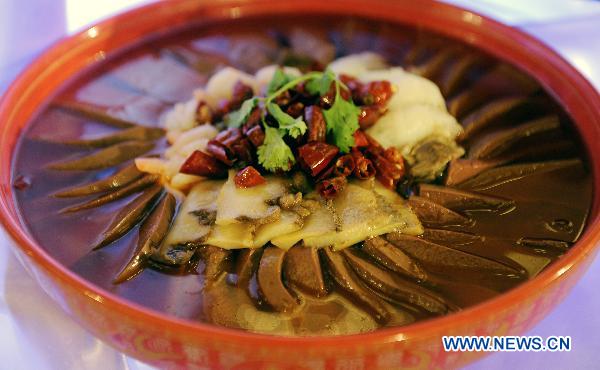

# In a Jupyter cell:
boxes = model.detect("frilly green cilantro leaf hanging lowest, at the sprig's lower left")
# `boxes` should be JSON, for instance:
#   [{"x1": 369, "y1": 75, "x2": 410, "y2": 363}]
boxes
[{"x1": 257, "y1": 126, "x2": 296, "y2": 172}]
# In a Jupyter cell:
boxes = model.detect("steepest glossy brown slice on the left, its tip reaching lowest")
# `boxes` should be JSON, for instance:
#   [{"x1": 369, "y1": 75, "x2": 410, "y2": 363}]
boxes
[{"x1": 113, "y1": 193, "x2": 177, "y2": 284}]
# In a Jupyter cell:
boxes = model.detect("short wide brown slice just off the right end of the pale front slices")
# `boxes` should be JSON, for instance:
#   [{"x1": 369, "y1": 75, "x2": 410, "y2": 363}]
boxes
[{"x1": 408, "y1": 195, "x2": 473, "y2": 227}]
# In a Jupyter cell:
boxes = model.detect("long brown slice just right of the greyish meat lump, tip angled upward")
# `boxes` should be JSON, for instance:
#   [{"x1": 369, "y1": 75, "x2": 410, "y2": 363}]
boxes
[{"x1": 468, "y1": 116, "x2": 560, "y2": 159}]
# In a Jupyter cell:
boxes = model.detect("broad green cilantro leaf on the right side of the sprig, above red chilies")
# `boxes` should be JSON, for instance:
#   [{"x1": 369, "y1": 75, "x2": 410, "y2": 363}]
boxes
[{"x1": 323, "y1": 92, "x2": 360, "y2": 153}]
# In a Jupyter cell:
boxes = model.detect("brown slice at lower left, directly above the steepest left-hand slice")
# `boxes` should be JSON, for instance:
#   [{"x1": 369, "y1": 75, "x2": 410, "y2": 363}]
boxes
[{"x1": 94, "y1": 185, "x2": 163, "y2": 250}]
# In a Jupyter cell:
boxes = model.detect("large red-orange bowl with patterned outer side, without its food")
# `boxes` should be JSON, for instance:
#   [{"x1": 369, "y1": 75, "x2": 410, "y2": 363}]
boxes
[{"x1": 0, "y1": 0, "x2": 600, "y2": 369}]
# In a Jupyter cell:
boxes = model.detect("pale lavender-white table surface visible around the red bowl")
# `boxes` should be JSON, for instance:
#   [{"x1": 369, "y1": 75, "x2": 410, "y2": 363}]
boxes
[{"x1": 0, "y1": 0, "x2": 600, "y2": 370}]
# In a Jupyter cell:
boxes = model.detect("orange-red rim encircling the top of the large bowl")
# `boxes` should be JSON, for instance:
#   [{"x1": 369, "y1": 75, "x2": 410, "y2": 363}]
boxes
[{"x1": 0, "y1": 0, "x2": 600, "y2": 348}]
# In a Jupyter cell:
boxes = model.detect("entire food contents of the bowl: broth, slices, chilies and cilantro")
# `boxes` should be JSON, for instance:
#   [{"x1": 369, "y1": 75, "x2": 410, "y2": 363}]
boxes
[{"x1": 13, "y1": 18, "x2": 592, "y2": 335}]
